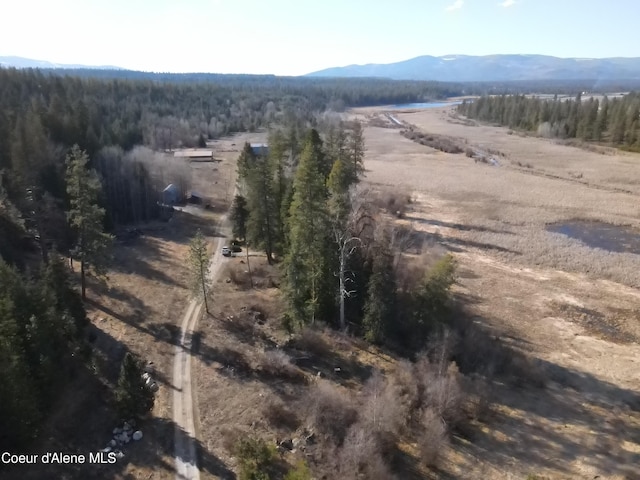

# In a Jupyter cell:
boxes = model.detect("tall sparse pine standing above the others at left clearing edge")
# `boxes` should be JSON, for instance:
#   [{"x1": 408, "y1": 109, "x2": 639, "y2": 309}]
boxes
[{"x1": 66, "y1": 145, "x2": 112, "y2": 300}]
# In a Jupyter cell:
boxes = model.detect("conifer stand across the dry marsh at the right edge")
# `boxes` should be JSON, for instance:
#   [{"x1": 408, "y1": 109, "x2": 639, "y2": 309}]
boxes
[{"x1": 458, "y1": 92, "x2": 640, "y2": 152}]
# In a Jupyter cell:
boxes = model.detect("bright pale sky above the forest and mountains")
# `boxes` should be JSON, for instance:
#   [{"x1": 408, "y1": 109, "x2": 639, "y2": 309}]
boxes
[{"x1": 0, "y1": 0, "x2": 640, "y2": 75}]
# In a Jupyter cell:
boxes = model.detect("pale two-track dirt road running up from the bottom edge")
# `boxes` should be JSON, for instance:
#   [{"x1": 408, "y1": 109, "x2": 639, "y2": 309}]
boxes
[{"x1": 173, "y1": 218, "x2": 226, "y2": 480}]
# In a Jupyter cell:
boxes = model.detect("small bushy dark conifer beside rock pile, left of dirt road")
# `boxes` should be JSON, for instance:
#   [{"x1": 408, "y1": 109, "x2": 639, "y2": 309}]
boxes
[{"x1": 115, "y1": 352, "x2": 154, "y2": 418}]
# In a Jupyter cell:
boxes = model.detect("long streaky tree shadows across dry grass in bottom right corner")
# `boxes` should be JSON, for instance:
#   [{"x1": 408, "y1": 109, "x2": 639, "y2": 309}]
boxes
[{"x1": 453, "y1": 304, "x2": 640, "y2": 478}]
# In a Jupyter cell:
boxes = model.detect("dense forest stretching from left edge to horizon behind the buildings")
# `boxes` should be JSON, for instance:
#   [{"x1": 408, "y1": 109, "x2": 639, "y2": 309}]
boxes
[{"x1": 0, "y1": 64, "x2": 470, "y2": 263}]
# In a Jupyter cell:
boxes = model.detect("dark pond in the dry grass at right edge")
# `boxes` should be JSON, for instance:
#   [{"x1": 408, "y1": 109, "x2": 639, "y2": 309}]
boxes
[{"x1": 547, "y1": 220, "x2": 640, "y2": 255}]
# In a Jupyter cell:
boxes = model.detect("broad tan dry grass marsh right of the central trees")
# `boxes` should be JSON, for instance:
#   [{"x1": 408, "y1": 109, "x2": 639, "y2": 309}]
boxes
[{"x1": 353, "y1": 108, "x2": 640, "y2": 479}]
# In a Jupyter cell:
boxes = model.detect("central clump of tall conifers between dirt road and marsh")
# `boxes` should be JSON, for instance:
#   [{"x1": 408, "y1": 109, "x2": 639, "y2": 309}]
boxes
[{"x1": 231, "y1": 122, "x2": 455, "y2": 351}]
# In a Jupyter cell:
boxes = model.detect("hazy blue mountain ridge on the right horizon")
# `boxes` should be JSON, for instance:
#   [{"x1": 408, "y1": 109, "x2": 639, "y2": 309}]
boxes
[{"x1": 306, "y1": 55, "x2": 640, "y2": 82}]
